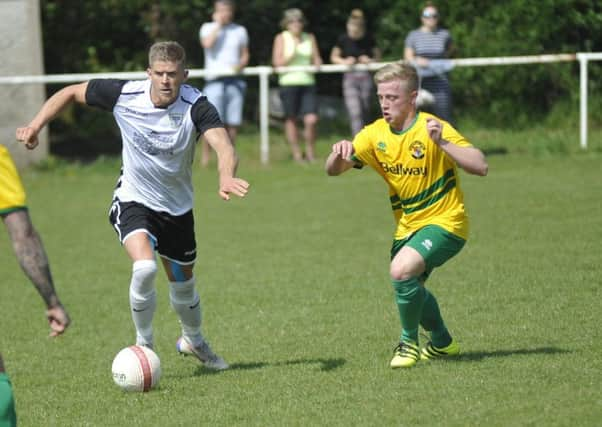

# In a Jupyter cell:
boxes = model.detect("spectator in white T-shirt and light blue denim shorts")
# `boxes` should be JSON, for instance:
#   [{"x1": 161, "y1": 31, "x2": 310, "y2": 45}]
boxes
[{"x1": 199, "y1": 0, "x2": 249, "y2": 166}]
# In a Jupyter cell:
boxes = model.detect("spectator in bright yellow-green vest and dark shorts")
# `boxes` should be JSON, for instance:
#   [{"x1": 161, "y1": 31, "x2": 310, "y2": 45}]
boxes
[{"x1": 272, "y1": 8, "x2": 322, "y2": 163}]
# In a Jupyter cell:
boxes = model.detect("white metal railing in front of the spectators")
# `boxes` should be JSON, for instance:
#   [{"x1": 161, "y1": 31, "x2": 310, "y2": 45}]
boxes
[{"x1": 0, "y1": 52, "x2": 602, "y2": 163}]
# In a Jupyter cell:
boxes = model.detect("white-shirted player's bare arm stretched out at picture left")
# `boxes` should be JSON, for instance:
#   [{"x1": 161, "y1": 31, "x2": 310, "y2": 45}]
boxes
[{"x1": 16, "y1": 82, "x2": 88, "y2": 150}]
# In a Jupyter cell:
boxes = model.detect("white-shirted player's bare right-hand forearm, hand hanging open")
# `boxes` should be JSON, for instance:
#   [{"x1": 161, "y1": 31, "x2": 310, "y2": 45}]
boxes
[{"x1": 203, "y1": 127, "x2": 249, "y2": 200}]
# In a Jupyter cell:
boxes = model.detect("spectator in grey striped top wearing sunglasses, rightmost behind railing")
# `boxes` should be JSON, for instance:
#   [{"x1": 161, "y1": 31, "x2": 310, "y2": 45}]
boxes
[{"x1": 404, "y1": 1, "x2": 454, "y2": 122}]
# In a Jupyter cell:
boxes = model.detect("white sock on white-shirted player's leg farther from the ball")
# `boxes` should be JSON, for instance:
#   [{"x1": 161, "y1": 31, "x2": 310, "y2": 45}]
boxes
[{"x1": 169, "y1": 277, "x2": 202, "y2": 346}]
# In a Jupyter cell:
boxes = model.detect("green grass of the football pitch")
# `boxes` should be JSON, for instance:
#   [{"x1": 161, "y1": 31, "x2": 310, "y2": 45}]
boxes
[{"x1": 0, "y1": 130, "x2": 602, "y2": 426}]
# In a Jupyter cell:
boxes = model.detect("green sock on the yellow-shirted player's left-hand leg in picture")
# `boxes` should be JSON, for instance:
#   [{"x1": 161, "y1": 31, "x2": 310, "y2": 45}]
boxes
[{"x1": 392, "y1": 277, "x2": 424, "y2": 344}]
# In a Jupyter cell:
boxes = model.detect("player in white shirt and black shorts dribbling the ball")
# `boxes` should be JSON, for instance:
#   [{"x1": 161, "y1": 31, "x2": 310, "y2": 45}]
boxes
[{"x1": 16, "y1": 41, "x2": 249, "y2": 370}]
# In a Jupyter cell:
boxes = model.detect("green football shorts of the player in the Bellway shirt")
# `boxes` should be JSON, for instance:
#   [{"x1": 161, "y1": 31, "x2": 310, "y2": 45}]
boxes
[{"x1": 391, "y1": 225, "x2": 466, "y2": 281}]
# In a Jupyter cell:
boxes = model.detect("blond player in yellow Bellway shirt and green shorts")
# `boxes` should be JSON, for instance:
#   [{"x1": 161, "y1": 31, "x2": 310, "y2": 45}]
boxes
[{"x1": 326, "y1": 62, "x2": 488, "y2": 368}]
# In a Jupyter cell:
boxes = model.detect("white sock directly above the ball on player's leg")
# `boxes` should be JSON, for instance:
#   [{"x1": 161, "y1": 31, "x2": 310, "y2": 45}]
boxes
[{"x1": 130, "y1": 259, "x2": 157, "y2": 346}]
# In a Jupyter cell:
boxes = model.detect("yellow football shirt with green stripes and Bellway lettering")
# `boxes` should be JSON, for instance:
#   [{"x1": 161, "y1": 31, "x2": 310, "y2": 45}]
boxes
[{"x1": 353, "y1": 112, "x2": 472, "y2": 239}]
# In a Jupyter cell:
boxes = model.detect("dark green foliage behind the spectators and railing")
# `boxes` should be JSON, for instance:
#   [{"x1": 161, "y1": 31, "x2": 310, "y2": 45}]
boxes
[{"x1": 41, "y1": 0, "x2": 602, "y2": 155}]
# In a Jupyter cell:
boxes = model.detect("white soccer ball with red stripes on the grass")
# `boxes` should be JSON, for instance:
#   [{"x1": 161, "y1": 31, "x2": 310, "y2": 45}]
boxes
[{"x1": 112, "y1": 345, "x2": 161, "y2": 391}]
